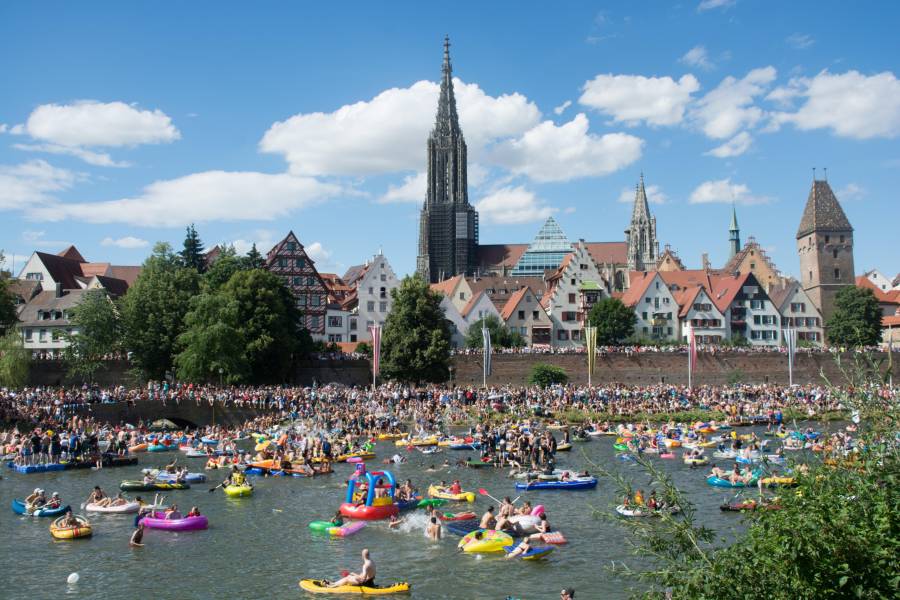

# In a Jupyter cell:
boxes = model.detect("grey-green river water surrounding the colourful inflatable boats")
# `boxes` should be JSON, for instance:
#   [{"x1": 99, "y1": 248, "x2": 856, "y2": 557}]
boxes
[{"x1": 0, "y1": 429, "x2": 816, "y2": 600}]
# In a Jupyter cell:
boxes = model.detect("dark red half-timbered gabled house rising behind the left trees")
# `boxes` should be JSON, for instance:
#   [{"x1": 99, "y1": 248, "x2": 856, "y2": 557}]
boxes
[{"x1": 265, "y1": 231, "x2": 328, "y2": 341}]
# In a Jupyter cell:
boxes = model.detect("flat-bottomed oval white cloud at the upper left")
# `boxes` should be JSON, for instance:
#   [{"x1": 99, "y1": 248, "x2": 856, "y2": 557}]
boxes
[{"x1": 25, "y1": 100, "x2": 181, "y2": 147}]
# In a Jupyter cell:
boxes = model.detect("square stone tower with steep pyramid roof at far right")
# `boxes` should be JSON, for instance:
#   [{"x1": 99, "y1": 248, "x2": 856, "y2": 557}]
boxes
[{"x1": 797, "y1": 178, "x2": 855, "y2": 322}]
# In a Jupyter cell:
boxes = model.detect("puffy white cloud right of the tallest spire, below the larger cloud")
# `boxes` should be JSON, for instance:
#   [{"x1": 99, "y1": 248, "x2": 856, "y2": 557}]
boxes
[{"x1": 491, "y1": 113, "x2": 643, "y2": 182}]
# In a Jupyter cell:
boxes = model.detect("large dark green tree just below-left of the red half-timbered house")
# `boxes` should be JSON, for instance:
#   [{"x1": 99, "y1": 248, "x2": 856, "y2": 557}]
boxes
[{"x1": 222, "y1": 269, "x2": 302, "y2": 382}]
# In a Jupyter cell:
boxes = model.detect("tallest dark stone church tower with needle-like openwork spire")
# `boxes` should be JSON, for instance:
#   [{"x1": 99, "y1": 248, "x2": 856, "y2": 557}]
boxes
[{"x1": 416, "y1": 38, "x2": 478, "y2": 283}]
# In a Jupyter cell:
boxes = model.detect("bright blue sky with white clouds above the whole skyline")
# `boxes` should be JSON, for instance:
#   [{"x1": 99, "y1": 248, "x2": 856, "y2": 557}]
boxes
[{"x1": 0, "y1": 0, "x2": 900, "y2": 275}]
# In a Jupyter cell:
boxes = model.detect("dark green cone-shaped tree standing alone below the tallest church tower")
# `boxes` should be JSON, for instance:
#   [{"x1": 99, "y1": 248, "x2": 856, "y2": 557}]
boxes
[{"x1": 381, "y1": 276, "x2": 450, "y2": 383}]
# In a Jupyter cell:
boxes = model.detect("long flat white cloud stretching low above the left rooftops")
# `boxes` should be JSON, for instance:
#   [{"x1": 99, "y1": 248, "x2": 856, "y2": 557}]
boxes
[{"x1": 27, "y1": 171, "x2": 340, "y2": 227}]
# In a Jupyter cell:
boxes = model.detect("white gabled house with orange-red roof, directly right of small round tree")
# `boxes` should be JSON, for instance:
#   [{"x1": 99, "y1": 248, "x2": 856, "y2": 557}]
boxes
[{"x1": 622, "y1": 271, "x2": 681, "y2": 341}]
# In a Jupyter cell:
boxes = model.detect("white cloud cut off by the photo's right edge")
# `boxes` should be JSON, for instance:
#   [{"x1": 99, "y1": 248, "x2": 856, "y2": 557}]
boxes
[{"x1": 769, "y1": 71, "x2": 900, "y2": 139}]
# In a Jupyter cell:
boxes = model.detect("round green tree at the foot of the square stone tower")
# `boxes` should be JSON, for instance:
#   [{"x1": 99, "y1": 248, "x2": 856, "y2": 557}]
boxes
[{"x1": 827, "y1": 285, "x2": 881, "y2": 346}]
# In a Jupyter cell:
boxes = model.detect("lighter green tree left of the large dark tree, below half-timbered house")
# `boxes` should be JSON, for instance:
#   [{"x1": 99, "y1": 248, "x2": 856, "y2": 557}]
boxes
[{"x1": 175, "y1": 290, "x2": 250, "y2": 383}]
